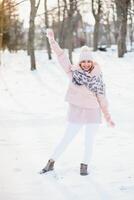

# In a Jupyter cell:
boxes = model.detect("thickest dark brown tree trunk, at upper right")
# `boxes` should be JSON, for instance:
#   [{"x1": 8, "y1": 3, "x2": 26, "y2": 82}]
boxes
[{"x1": 115, "y1": 0, "x2": 130, "y2": 57}]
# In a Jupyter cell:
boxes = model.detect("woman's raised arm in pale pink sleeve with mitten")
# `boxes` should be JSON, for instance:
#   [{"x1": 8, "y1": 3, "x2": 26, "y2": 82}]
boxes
[{"x1": 47, "y1": 29, "x2": 72, "y2": 76}]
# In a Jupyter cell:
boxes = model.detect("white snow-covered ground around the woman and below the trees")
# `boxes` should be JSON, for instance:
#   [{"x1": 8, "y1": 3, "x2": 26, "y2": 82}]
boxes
[{"x1": 0, "y1": 50, "x2": 134, "y2": 200}]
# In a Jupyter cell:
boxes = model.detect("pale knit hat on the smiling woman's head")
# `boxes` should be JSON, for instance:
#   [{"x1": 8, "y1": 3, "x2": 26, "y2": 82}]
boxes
[{"x1": 79, "y1": 46, "x2": 93, "y2": 63}]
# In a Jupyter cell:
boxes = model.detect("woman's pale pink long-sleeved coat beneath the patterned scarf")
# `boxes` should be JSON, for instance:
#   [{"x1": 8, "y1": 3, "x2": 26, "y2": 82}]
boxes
[{"x1": 49, "y1": 38, "x2": 111, "y2": 121}]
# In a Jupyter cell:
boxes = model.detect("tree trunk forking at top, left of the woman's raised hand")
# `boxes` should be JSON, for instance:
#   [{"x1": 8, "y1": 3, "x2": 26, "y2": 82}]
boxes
[{"x1": 28, "y1": 0, "x2": 40, "y2": 70}]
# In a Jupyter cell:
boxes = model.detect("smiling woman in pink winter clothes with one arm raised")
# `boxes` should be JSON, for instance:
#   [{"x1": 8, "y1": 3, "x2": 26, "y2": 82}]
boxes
[{"x1": 40, "y1": 29, "x2": 115, "y2": 175}]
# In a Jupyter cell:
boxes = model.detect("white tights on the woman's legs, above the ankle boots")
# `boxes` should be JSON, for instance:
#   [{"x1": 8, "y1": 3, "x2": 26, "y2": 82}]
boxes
[{"x1": 50, "y1": 123, "x2": 99, "y2": 164}]
